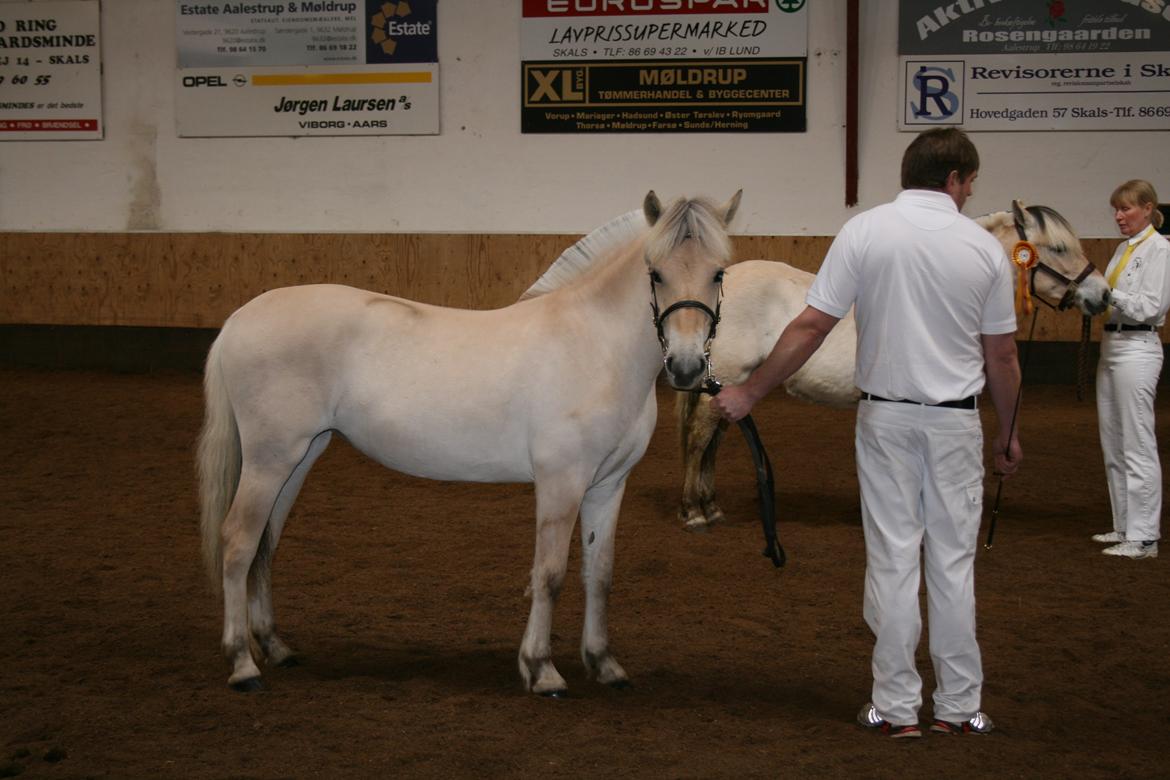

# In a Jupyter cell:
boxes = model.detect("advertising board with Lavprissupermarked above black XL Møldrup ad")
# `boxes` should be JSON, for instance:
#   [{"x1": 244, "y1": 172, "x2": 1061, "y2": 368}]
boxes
[{"x1": 521, "y1": 0, "x2": 808, "y2": 133}]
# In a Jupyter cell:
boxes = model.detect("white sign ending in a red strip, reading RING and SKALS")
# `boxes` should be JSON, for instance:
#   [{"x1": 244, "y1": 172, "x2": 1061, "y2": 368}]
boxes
[{"x1": 0, "y1": 0, "x2": 105, "y2": 140}]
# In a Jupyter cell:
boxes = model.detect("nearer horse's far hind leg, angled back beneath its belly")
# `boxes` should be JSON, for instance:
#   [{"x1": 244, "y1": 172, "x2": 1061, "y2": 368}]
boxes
[{"x1": 248, "y1": 430, "x2": 332, "y2": 665}]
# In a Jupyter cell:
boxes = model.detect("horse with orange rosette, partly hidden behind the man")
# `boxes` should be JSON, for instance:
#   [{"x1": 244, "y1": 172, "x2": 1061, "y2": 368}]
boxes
[{"x1": 675, "y1": 201, "x2": 1109, "y2": 530}]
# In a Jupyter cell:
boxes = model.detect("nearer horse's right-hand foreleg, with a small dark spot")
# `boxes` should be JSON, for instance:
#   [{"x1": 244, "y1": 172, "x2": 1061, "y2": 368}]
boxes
[{"x1": 580, "y1": 475, "x2": 629, "y2": 688}]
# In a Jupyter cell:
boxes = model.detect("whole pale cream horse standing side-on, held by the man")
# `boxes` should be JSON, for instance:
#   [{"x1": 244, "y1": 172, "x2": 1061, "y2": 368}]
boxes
[{"x1": 198, "y1": 192, "x2": 739, "y2": 696}]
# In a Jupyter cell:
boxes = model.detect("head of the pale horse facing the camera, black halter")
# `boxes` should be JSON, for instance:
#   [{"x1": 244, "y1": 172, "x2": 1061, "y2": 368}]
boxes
[{"x1": 642, "y1": 189, "x2": 743, "y2": 389}]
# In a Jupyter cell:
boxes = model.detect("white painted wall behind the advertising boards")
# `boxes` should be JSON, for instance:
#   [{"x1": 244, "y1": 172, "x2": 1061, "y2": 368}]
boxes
[{"x1": 0, "y1": 0, "x2": 1170, "y2": 237}]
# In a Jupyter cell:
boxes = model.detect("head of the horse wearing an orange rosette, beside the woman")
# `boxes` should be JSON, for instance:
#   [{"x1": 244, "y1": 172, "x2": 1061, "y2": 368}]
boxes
[{"x1": 1009, "y1": 200, "x2": 1109, "y2": 315}]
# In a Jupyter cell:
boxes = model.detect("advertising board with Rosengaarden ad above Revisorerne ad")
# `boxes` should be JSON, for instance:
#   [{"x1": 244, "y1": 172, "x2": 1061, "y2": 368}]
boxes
[{"x1": 897, "y1": 0, "x2": 1170, "y2": 131}]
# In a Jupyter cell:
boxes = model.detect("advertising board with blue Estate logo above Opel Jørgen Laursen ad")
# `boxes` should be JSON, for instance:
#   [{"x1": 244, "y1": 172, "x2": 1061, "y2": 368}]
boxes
[{"x1": 176, "y1": 0, "x2": 439, "y2": 137}]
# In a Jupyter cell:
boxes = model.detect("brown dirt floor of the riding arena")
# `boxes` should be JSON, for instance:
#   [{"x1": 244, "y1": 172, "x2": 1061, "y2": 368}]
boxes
[{"x1": 0, "y1": 370, "x2": 1170, "y2": 779}]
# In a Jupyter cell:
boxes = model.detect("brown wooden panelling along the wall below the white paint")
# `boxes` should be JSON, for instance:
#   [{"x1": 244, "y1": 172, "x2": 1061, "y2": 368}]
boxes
[{"x1": 0, "y1": 233, "x2": 1151, "y2": 340}]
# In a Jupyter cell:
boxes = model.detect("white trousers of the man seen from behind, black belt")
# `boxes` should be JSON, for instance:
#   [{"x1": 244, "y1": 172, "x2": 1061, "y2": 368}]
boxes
[{"x1": 855, "y1": 401, "x2": 983, "y2": 725}]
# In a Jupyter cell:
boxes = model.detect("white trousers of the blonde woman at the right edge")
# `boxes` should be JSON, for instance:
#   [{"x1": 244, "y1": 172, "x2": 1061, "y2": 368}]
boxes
[{"x1": 1096, "y1": 331, "x2": 1162, "y2": 541}]
